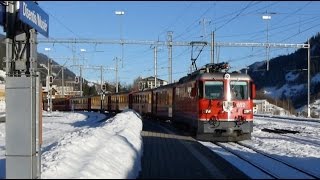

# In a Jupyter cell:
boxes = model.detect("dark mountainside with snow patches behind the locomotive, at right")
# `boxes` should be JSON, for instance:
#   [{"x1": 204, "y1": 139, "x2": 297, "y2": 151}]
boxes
[{"x1": 241, "y1": 33, "x2": 320, "y2": 112}]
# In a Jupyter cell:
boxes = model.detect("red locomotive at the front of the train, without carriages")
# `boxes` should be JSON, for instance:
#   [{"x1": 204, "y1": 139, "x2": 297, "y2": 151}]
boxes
[{"x1": 173, "y1": 63, "x2": 255, "y2": 141}]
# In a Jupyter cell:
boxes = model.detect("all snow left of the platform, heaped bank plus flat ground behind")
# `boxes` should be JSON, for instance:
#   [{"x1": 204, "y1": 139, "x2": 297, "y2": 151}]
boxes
[{"x1": 0, "y1": 110, "x2": 143, "y2": 179}]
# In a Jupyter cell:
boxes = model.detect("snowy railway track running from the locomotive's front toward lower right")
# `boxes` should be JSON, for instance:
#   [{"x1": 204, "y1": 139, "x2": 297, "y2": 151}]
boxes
[{"x1": 213, "y1": 143, "x2": 320, "y2": 179}]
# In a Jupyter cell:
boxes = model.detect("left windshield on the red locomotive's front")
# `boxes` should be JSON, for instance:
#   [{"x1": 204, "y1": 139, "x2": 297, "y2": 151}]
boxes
[{"x1": 204, "y1": 81, "x2": 224, "y2": 99}]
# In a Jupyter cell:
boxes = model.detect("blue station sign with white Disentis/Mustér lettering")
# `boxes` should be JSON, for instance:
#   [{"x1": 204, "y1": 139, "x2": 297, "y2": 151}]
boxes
[{"x1": 18, "y1": 1, "x2": 49, "y2": 37}]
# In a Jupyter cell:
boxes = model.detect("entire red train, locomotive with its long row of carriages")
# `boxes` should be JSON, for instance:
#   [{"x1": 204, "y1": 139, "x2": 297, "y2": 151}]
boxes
[{"x1": 44, "y1": 63, "x2": 256, "y2": 141}]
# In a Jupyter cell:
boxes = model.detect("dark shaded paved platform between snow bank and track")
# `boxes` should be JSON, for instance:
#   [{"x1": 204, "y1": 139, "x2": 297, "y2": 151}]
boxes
[{"x1": 138, "y1": 120, "x2": 248, "y2": 179}]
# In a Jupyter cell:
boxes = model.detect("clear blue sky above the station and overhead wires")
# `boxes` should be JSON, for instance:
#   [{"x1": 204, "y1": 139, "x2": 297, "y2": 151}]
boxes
[{"x1": 3, "y1": 1, "x2": 320, "y2": 84}]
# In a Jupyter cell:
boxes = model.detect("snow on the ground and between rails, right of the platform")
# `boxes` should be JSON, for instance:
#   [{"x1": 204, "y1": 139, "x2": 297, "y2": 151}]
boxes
[{"x1": 201, "y1": 117, "x2": 320, "y2": 179}]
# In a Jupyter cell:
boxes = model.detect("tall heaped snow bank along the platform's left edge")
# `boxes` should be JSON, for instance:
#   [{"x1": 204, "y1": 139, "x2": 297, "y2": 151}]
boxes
[{"x1": 41, "y1": 110, "x2": 143, "y2": 179}]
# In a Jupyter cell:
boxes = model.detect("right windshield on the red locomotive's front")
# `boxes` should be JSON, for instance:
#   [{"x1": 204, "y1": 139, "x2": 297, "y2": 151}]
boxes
[{"x1": 230, "y1": 81, "x2": 249, "y2": 100}]
